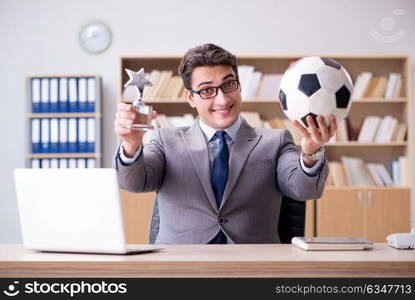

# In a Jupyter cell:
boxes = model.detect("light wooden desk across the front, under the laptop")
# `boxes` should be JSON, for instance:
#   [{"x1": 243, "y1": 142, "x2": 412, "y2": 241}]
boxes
[{"x1": 0, "y1": 244, "x2": 415, "y2": 278}]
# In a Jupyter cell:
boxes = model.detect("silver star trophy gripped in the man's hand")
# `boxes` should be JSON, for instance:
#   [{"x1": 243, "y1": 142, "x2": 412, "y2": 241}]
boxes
[{"x1": 123, "y1": 68, "x2": 154, "y2": 131}]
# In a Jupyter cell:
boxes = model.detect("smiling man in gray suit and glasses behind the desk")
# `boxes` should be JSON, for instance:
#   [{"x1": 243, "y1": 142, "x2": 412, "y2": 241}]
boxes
[{"x1": 114, "y1": 44, "x2": 336, "y2": 244}]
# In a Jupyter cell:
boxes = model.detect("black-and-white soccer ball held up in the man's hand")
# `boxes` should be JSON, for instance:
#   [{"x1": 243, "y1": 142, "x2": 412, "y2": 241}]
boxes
[{"x1": 279, "y1": 56, "x2": 353, "y2": 127}]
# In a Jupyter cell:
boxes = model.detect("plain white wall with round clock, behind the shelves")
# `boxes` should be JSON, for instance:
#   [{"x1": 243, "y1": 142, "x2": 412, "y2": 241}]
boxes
[{"x1": 0, "y1": 0, "x2": 415, "y2": 243}]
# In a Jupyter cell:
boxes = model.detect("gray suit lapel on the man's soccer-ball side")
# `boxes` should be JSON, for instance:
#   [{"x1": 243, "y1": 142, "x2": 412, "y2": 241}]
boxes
[{"x1": 221, "y1": 120, "x2": 262, "y2": 207}]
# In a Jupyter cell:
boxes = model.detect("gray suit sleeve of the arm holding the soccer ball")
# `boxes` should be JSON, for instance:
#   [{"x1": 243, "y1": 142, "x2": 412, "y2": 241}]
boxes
[{"x1": 276, "y1": 130, "x2": 329, "y2": 200}]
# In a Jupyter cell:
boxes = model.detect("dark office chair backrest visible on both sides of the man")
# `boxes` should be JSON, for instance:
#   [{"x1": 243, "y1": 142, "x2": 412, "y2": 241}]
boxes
[{"x1": 150, "y1": 196, "x2": 306, "y2": 244}]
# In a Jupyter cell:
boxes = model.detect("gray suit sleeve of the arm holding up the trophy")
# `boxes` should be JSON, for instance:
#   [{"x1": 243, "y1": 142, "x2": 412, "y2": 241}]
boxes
[{"x1": 113, "y1": 129, "x2": 165, "y2": 193}]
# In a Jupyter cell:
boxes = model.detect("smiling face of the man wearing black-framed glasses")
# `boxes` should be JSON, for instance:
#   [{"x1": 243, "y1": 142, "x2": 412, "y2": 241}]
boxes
[{"x1": 186, "y1": 65, "x2": 241, "y2": 130}]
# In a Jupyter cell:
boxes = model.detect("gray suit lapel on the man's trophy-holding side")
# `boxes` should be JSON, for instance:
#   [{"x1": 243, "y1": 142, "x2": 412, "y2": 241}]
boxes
[{"x1": 181, "y1": 121, "x2": 218, "y2": 211}]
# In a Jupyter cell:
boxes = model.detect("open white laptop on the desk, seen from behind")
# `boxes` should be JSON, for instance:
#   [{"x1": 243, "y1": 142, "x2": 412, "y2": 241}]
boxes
[{"x1": 14, "y1": 169, "x2": 162, "y2": 254}]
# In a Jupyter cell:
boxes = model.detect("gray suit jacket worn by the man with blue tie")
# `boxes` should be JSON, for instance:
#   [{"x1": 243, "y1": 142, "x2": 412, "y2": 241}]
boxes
[{"x1": 114, "y1": 121, "x2": 328, "y2": 244}]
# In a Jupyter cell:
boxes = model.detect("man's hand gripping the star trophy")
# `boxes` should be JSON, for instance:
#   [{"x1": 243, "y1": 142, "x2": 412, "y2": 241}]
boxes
[{"x1": 114, "y1": 103, "x2": 157, "y2": 157}]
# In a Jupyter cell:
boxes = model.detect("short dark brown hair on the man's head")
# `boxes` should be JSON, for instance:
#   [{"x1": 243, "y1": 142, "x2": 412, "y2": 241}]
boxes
[{"x1": 179, "y1": 44, "x2": 239, "y2": 90}]
